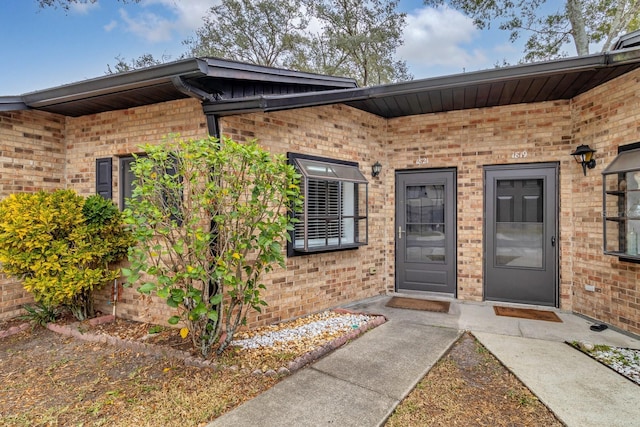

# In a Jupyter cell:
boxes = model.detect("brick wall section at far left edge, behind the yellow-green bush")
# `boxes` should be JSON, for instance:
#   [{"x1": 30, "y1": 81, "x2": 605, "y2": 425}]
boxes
[{"x1": 0, "y1": 111, "x2": 65, "y2": 319}]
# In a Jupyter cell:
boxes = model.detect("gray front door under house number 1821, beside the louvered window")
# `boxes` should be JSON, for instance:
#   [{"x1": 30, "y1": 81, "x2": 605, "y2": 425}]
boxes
[{"x1": 395, "y1": 169, "x2": 456, "y2": 294}]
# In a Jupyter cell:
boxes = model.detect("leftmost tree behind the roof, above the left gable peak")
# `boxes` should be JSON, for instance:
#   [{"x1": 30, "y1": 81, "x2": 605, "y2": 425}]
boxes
[{"x1": 185, "y1": 0, "x2": 309, "y2": 67}]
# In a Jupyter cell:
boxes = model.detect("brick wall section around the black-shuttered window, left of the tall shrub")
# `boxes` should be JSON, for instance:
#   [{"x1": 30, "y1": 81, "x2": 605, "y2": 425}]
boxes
[{"x1": 65, "y1": 99, "x2": 208, "y2": 323}]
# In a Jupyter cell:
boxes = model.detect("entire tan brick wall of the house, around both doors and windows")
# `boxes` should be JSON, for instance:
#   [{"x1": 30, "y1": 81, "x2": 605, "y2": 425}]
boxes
[{"x1": 0, "y1": 67, "x2": 640, "y2": 333}]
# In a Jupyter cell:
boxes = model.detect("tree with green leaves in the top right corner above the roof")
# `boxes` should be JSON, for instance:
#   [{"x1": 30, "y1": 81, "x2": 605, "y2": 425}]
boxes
[{"x1": 424, "y1": 0, "x2": 640, "y2": 62}]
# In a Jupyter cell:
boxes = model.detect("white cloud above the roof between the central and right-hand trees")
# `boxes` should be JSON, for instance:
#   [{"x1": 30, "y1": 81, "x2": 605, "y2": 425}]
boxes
[{"x1": 397, "y1": 6, "x2": 487, "y2": 78}]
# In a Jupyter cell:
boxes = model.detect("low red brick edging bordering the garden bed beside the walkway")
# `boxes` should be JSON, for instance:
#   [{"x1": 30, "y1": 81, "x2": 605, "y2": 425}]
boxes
[{"x1": 43, "y1": 309, "x2": 387, "y2": 376}]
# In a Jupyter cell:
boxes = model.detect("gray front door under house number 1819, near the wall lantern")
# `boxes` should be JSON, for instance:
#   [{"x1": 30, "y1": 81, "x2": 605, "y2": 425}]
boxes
[{"x1": 484, "y1": 164, "x2": 558, "y2": 306}]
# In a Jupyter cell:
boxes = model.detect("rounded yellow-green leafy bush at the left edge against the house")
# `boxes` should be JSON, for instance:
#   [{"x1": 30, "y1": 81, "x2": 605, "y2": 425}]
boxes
[{"x1": 0, "y1": 190, "x2": 132, "y2": 320}]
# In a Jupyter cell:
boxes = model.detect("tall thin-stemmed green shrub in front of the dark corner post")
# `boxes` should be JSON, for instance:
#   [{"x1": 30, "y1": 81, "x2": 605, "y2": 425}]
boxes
[{"x1": 122, "y1": 138, "x2": 300, "y2": 357}]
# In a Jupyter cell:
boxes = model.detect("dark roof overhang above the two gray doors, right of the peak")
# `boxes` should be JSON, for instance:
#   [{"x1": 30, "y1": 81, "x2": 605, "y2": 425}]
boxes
[{"x1": 204, "y1": 48, "x2": 640, "y2": 118}]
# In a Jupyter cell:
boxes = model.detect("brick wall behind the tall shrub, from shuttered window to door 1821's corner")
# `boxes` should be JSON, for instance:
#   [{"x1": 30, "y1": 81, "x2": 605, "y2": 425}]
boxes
[{"x1": 72, "y1": 100, "x2": 393, "y2": 325}]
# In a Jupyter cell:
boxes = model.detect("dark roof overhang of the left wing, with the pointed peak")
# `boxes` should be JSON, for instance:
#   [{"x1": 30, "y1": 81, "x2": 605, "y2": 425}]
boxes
[{"x1": 12, "y1": 58, "x2": 356, "y2": 116}]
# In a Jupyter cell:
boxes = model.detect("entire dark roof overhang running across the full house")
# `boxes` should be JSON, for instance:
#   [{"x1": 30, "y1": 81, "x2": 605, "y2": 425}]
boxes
[{"x1": 0, "y1": 44, "x2": 640, "y2": 118}]
